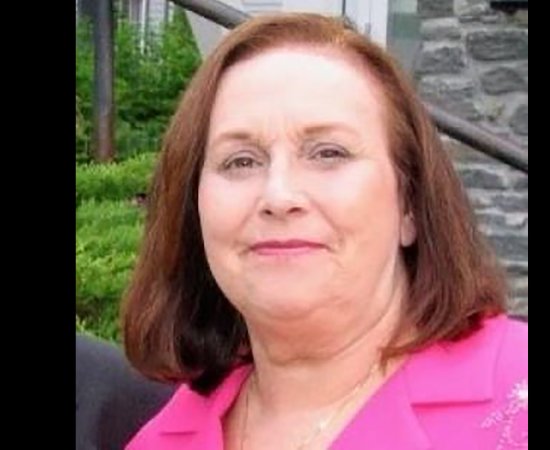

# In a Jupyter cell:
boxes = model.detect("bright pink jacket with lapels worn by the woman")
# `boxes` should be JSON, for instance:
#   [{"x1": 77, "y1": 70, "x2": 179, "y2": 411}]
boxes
[{"x1": 126, "y1": 316, "x2": 528, "y2": 450}]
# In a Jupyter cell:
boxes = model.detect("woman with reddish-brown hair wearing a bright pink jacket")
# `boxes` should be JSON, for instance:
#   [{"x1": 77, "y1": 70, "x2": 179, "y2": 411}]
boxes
[{"x1": 123, "y1": 14, "x2": 527, "y2": 450}]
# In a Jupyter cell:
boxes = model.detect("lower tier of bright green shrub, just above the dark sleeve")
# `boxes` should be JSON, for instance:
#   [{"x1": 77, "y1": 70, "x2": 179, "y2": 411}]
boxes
[{"x1": 76, "y1": 200, "x2": 148, "y2": 341}]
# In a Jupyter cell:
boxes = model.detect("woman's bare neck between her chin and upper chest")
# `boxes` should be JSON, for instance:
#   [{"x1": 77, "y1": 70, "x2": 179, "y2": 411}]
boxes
[{"x1": 249, "y1": 278, "x2": 410, "y2": 417}]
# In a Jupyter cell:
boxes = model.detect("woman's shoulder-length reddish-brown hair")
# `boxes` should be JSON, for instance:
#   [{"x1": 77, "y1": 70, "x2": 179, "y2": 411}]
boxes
[{"x1": 121, "y1": 13, "x2": 506, "y2": 393}]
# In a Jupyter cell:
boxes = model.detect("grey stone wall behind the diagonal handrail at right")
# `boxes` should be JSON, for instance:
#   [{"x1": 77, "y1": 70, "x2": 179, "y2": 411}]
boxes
[{"x1": 414, "y1": 0, "x2": 528, "y2": 315}]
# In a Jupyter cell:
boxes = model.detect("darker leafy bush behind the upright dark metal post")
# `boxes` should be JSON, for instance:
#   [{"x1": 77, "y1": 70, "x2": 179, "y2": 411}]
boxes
[{"x1": 76, "y1": 13, "x2": 200, "y2": 162}]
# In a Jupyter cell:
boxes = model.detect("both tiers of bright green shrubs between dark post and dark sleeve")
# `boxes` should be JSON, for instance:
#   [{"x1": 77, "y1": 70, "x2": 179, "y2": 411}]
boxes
[{"x1": 76, "y1": 153, "x2": 157, "y2": 341}]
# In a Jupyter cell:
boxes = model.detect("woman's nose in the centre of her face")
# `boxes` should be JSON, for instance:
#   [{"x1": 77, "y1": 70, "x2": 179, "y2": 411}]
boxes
[{"x1": 260, "y1": 161, "x2": 307, "y2": 220}]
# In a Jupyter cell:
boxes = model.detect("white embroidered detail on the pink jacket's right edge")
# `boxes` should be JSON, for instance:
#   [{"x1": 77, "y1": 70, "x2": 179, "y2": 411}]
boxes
[{"x1": 481, "y1": 379, "x2": 529, "y2": 450}]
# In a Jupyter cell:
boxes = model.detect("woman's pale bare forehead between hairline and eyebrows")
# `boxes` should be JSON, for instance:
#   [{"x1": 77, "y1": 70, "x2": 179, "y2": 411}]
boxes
[{"x1": 212, "y1": 47, "x2": 385, "y2": 133}]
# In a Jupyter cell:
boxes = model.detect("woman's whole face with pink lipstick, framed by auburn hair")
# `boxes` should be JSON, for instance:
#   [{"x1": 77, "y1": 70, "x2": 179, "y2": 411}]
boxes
[{"x1": 199, "y1": 48, "x2": 414, "y2": 320}]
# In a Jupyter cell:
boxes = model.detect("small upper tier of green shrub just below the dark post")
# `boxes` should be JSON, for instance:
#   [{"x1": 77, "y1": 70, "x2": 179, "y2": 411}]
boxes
[{"x1": 76, "y1": 153, "x2": 157, "y2": 206}]
